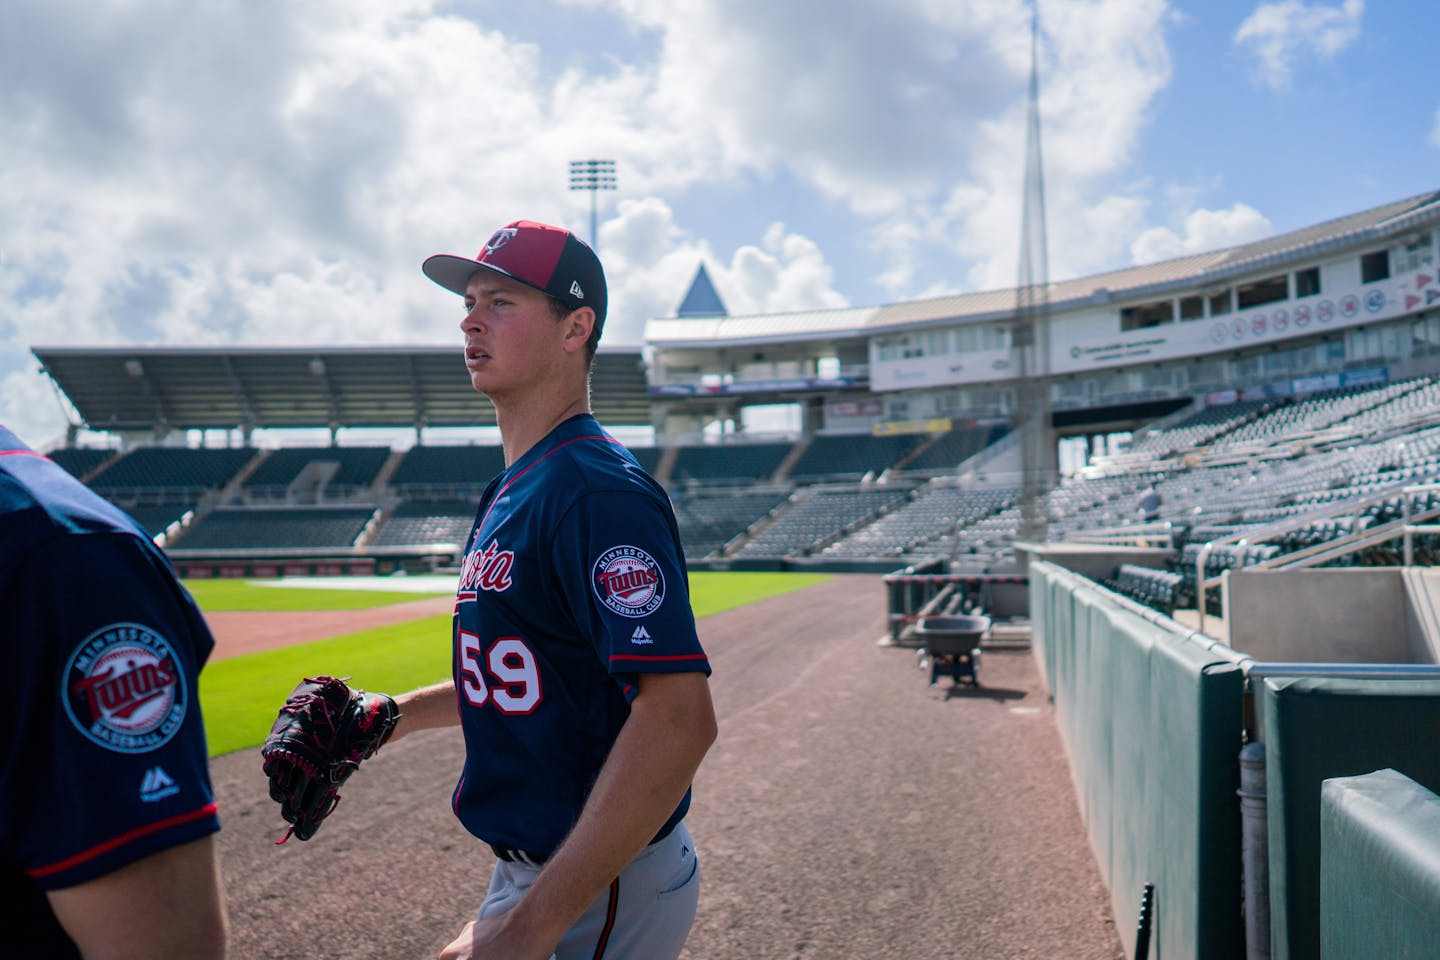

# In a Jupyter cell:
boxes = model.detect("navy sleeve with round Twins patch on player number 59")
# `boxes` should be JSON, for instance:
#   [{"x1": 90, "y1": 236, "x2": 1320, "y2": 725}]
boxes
[{"x1": 553, "y1": 491, "x2": 710, "y2": 697}]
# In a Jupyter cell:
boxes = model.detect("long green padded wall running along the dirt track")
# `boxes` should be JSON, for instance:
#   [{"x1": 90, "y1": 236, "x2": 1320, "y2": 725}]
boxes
[{"x1": 1030, "y1": 563, "x2": 1244, "y2": 960}]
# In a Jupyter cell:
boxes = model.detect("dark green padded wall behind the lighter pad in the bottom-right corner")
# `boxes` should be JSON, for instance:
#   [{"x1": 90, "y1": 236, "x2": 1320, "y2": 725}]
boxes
[{"x1": 1263, "y1": 676, "x2": 1440, "y2": 960}]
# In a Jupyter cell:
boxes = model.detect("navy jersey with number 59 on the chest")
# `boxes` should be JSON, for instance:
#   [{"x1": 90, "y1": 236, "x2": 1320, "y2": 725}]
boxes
[{"x1": 454, "y1": 415, "x2": 710, "y2": 856}]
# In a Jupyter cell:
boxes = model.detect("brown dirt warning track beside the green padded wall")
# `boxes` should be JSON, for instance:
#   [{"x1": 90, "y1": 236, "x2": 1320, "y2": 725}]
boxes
[{"x1": 215, "y1": 576, "x2": 1122, "y2": 960}]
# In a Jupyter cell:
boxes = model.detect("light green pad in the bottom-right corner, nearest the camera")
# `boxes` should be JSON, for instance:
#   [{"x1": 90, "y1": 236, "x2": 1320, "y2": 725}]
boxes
[{"x1": 1320, "y1": 770, "x2": 1440, "y2": 960}]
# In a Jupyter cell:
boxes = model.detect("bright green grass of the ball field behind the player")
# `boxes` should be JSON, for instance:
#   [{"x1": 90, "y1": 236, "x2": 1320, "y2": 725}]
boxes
[{"x1": 195, "y1": 571, "x2": 829, "y2": 756}]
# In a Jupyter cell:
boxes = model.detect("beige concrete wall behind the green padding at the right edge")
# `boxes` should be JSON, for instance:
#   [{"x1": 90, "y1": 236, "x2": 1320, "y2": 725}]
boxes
[{"x1": 1224, "y1": 567, "x2": 1440, "y2": 664}]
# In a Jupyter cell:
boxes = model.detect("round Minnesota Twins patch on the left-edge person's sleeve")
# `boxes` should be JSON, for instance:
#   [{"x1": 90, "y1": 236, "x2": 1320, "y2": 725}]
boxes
[{"x1": 62, "y1": 623, "x2": 189, "y2": 753}]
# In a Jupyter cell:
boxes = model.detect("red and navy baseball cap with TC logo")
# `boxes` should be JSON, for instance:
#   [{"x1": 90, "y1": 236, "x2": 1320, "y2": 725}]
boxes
[{"x1": 420, "y1": 220, "x2": 606, "y2": 330}]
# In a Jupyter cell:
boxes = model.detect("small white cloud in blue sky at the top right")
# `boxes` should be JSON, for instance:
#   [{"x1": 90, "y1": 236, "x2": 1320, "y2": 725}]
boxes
[{"x1": 1234, "y1": 0, "x2": 1365, "y2": 89}]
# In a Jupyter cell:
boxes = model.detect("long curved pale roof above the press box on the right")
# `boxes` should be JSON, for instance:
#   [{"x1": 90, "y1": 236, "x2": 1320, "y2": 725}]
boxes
[{"x1": 645, "y1": 191, "x2": 1440, "y2": 348}]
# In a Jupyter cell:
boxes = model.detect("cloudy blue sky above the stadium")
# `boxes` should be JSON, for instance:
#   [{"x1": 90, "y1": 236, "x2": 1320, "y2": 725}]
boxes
[{"x1": 0, "y1": 0, "x2": 1440, "y2": 446}]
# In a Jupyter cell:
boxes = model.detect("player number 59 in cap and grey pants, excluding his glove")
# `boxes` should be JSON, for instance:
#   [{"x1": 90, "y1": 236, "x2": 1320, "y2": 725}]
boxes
[{"x1": 395, "y1": 220, "x2": 716, "y2": 960}]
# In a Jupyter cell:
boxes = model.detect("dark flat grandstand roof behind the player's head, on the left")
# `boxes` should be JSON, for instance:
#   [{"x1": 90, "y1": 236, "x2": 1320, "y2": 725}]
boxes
[{"x1": 33, "y1": 347, "x2": 649, "y2": 430}]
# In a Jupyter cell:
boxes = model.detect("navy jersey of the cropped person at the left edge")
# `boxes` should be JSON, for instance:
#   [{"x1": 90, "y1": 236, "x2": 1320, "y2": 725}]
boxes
[{"x1": 0, "y1": 429, "x2": 219, "y2": 957}]
